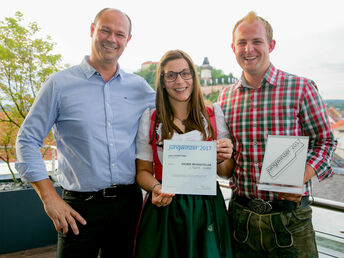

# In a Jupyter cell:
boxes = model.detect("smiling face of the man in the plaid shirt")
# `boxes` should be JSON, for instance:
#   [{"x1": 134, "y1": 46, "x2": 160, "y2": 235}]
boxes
[{"x1": 232, "y1": 20, "x2": 275, "y2": 80}]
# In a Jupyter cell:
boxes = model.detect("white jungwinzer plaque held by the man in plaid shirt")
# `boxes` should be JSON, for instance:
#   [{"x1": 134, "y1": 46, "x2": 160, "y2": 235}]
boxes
[{"x1": 258, "y1": 135, "x2": 309, "y2": 194}]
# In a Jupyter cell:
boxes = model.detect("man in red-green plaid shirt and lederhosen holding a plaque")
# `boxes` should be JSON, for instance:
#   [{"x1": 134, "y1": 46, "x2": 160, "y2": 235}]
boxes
[{"x1": 218, "y1": 12, "x2": 336, "y2": 257}]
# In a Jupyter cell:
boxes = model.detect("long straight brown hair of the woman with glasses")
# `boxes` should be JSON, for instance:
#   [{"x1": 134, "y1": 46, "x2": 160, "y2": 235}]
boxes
[{"x1": 151, "y1": 50, "x2": 215, "y2": 142}]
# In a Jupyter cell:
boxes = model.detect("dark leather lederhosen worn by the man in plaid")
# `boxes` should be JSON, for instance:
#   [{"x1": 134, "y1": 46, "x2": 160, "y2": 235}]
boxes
[{"x1": 229, "y1": 200, "x2": 318, "y2": 258}]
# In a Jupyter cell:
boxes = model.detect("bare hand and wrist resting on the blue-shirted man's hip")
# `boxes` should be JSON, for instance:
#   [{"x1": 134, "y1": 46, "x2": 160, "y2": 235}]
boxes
[{"x1": 32, "y1": 179, "x2": 86, "y2": 235}]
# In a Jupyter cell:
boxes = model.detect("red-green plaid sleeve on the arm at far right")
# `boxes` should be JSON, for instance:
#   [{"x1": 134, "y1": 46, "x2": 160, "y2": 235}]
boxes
[{"x1": 300, "y1": 81, "x2": 337, "y2": 181}]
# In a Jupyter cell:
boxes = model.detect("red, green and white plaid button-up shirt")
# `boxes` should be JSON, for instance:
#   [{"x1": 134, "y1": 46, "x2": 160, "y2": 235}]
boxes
[{"x1": 218, "y1": 64, "x2": 336, "y2": 200}]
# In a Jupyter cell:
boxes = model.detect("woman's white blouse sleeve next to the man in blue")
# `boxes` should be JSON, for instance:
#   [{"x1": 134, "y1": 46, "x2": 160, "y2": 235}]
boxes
[{"x1": 135, "y1": 108, "x2": 153, "y2": 162}]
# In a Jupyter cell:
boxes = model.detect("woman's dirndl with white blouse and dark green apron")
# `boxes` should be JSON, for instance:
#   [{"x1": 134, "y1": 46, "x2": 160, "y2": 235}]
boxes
[{"x1": 134, "y1": 104, "x2": 232, "y2": 258}]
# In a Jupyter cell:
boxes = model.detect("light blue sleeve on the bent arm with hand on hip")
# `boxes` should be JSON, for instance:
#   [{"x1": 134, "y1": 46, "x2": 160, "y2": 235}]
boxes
[{"x1": 15, "y1": 75, "x2": 57, "y2": 182}]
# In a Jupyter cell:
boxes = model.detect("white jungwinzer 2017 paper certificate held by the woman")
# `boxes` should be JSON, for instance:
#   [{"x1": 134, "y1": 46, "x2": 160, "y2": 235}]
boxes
[{"x1": 162, "y1": 140, "x2": 216, "y2": 195}]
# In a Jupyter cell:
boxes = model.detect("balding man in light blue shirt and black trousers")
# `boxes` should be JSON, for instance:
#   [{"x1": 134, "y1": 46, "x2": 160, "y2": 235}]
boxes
[{"x1": 16, "y1": 8, "x2": 155, "y2": 257}]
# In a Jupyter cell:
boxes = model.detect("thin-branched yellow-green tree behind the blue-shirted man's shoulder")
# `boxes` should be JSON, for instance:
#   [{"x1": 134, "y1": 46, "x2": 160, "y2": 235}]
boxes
[{"x1": 0, "y1": 12, "x2": 61, "y2": 181}]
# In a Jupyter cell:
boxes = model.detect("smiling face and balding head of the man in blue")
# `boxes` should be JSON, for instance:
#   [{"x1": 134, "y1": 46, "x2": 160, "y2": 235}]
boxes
[{"x1": 90, "y1": 10, "x2": 131, "y2": 66}]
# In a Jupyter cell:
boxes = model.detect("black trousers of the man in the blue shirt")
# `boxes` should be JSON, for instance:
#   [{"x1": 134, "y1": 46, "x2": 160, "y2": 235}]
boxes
[{"x1": 57, "y1": 186, "x2": 142, "y2": 258}]
